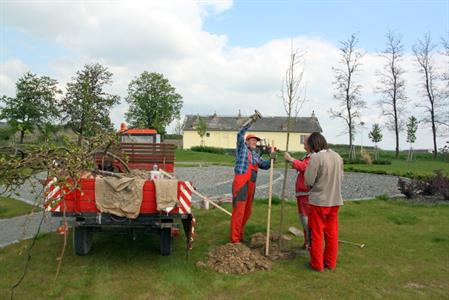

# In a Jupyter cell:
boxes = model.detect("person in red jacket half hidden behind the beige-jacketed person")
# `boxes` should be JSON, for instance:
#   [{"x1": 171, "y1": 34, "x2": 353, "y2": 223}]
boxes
[{"x1": 284, "y1": 138, "x2": 310, "y2": 249}]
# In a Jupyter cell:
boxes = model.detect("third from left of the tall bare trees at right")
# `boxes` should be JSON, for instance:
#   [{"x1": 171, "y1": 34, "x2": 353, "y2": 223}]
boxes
[{"x1": 413, "y1": 33, "x2": 442, "y2": 157}]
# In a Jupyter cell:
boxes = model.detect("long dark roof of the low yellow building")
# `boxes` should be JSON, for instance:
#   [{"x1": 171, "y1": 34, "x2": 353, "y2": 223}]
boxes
[{"x1": 184, "y1": 114, "x2": 323, "y2": 133}]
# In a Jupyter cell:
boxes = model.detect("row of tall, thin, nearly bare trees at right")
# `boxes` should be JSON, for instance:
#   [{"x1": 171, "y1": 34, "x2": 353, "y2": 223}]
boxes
[{"x1": 329, "y1": 31, "x2": 449, "y2": 158}]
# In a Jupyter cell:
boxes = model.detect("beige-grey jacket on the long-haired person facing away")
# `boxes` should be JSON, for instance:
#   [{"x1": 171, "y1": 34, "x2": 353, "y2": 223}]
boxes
[{"x1": 304, "y1": 149, "x2": 343, "y2": 206}]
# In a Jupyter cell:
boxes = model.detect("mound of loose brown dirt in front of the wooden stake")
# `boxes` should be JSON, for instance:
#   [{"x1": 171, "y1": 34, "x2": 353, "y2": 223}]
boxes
[{"x1": 197, "y1": 243, "x2": 272, "y2": 274}]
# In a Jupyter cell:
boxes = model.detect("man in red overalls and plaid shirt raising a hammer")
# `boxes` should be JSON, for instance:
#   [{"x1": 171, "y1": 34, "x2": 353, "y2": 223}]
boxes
[{"x1": 231, "y1": 116, "x2": 273, "y2": 243}]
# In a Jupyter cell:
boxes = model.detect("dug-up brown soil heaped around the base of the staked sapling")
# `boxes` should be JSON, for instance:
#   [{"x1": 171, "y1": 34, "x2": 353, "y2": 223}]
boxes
[{"x1": 197, "y1": 232, "x2": 296, "y2": 274}]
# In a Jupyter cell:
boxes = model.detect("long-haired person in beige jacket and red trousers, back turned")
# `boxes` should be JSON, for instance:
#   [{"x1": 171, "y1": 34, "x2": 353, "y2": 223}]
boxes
[{"x1": 304, "y1": 132, "x2": 343, "y2": 272}]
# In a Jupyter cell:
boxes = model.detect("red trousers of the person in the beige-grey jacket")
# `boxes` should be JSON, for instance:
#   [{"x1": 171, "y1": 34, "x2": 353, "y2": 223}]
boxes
[{"x1": 309, "y1": 205, "x2": 340, "y2": 271}]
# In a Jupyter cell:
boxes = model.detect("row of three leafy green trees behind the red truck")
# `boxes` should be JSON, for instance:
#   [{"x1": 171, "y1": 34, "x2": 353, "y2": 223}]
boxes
[{"x1": 0, "y1": 63, "x2": 183, "y2": 144}]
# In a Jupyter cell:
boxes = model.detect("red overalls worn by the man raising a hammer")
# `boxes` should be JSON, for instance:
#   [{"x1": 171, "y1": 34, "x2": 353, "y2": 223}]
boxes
[{"x1": 231, "y1": 151, "x2": 259, "y2": 243}]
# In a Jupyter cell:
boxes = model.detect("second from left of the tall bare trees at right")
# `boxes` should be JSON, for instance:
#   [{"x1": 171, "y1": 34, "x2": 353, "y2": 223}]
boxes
[{"x1": 376, "y1": 31, "x2": 407, "y2": 158}]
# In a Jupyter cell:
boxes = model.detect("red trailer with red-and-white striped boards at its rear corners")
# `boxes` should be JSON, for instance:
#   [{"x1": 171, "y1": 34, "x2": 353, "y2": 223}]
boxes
[{"x1": 45, "y1": 178, "x2": 195, "y2": 255}]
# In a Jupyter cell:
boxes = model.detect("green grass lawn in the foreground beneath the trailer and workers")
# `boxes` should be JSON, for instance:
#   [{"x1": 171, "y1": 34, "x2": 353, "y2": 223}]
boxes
[{"x1": 0, "y1": 200, "x2": 449, "y2": 299}]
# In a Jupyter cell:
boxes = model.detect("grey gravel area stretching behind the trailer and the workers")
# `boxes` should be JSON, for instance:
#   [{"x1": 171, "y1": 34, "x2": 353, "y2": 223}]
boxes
[{"x1": 0, "y1": 166, "x2": 399, "y2": 248}]
